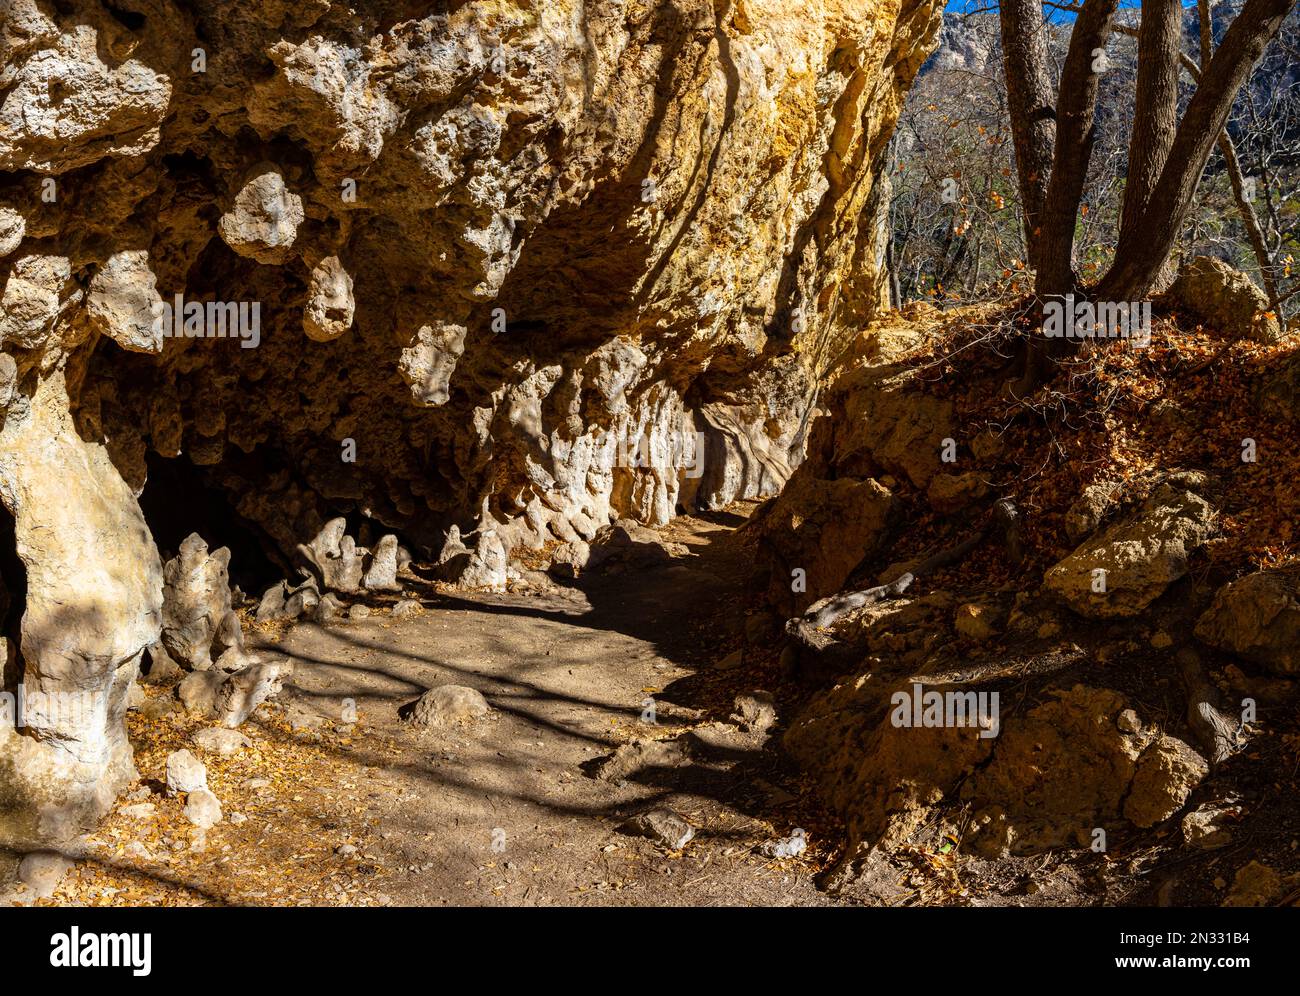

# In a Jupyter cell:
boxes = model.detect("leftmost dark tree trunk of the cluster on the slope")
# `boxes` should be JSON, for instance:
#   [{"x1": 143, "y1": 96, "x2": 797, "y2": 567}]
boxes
[{"x1": 998, "y1": 0, "x2": 1056, "y2": 268}]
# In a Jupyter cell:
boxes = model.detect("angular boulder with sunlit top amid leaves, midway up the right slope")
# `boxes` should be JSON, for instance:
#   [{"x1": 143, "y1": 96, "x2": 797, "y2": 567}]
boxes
[{"x1": 1044, "y1": 484, "x2": 1216, "y2": 619}]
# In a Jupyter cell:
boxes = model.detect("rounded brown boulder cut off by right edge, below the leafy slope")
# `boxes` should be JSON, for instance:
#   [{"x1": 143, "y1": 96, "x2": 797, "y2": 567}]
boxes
[{"x1": 1196, "y1": 570, "x2": 1300, "y2": 675}]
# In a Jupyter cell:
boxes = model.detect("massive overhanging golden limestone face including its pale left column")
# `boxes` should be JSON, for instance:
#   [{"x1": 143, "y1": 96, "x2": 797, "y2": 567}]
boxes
[{"x1": 0, "y1": 0, "x2": 941, "y2": 847}]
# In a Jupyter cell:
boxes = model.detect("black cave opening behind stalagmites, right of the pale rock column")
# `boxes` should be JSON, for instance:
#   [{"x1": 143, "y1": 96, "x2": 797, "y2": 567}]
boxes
[{"x1": 140, "y1": 452, "x2": 285, "y2": 598}]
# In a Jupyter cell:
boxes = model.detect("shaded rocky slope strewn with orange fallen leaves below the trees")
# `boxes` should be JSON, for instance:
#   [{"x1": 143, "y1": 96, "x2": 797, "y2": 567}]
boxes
[{"x1": 751, "y1": 286, "x2": 1300, "y2": 905}]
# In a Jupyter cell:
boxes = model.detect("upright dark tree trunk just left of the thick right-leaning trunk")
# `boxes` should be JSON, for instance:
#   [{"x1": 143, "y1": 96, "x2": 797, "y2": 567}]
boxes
[{"x1": 1117, "y1": 0, "x2": 1183, "y2": 292}]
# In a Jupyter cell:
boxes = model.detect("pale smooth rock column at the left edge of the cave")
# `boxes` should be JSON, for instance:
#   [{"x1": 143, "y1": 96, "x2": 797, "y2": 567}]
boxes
[{"x1": 0, "y1": 372, "x2": 163, "y2": 846}]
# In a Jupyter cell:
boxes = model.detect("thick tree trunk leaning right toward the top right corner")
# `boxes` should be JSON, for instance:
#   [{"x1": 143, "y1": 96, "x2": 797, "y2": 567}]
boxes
[{"x1": 1097, "y1": 0, "x2": 1294, "y2": 300}]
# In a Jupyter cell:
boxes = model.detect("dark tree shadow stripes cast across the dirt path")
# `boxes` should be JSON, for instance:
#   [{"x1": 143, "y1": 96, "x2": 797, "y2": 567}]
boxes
[{"x1": 228, "y1": 512, "x2": 792, "y2": 858}]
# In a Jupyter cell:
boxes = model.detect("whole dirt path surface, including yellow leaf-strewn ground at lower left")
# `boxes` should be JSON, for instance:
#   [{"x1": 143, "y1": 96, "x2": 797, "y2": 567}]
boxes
[{"x1": 15, "y1": 514, "x2": 847, "y2": 905}]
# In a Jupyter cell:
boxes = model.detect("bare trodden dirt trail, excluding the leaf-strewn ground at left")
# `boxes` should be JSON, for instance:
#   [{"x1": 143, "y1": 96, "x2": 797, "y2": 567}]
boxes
[{"x1": 273, "y1": 509, "x2": 826, "y2": 905}]
